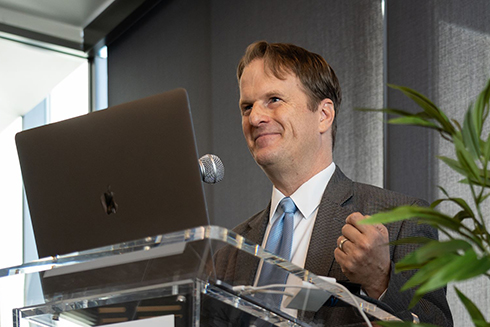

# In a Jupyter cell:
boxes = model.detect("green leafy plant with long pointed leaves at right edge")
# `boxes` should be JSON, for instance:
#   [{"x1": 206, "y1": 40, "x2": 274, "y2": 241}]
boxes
[{"x1": 358, "y1": 81, "x2": 490, "y2": 327}]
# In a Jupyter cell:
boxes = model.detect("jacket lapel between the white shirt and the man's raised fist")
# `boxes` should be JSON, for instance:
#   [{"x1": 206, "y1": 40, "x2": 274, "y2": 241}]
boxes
[{"x1": 305, "y1": 167, "x2": 353, "y2": 279}]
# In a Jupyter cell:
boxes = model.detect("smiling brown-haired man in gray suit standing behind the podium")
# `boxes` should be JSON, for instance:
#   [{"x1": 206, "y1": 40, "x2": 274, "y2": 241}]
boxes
[{"x1": 214, "y1": 41, "x2": 452, "y2": 326}]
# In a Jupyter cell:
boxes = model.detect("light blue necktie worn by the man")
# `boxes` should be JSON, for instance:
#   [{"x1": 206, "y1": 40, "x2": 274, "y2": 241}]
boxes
[{"x1": 257, "y1": 197, "x2": 297, "y2": 307}]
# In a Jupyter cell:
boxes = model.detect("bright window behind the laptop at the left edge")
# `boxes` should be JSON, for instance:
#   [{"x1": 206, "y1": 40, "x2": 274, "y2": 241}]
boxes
[{"x1": 0, "y1": 35, "x2": 107, "y2": 326}]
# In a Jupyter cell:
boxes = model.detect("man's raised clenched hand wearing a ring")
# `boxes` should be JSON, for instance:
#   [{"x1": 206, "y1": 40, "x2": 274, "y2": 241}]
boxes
[{"x1": 334, "y1": 212, "x2": 391, "y2": 299}]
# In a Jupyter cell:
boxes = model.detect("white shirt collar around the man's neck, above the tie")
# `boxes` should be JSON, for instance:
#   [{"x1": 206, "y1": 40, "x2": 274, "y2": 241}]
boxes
[{"x1": 269, "y1": 162, "x2": 335, "y2": 222}]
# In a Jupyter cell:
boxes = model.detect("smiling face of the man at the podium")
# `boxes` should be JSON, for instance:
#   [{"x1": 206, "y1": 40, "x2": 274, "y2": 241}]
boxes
[{"x1": 240, "y1": 59, "x2": 325, "y2": 170}]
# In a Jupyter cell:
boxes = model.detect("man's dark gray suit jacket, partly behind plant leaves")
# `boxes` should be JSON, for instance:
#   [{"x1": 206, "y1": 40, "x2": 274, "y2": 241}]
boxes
[{"x1": 217, "y1": 167, "x2": 452, "y2": 326}]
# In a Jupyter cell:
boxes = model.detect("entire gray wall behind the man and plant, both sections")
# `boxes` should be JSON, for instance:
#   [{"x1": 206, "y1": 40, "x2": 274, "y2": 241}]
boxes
[{"x1": 109, "y1": 0, "x2": 490, "y2": 326}]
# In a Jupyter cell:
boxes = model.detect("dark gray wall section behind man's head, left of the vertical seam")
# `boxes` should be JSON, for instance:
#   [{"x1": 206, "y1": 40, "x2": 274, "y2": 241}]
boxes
[{"x1": 108, "y1": 0, "x2": 383, "y2": 227}]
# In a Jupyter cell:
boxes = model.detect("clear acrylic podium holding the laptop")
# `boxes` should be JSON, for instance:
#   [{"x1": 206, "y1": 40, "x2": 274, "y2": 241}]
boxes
[{"x1": 0, "y1": 226, "x2": 398, "y2": 327}]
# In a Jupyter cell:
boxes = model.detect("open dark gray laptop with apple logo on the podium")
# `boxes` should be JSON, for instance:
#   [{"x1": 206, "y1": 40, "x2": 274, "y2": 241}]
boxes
[{"x1": 16, "y1": 89, "x2": 210, "y2": 258}]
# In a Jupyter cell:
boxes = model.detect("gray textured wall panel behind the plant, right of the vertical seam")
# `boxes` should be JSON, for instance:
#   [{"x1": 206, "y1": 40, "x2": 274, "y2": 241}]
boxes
[{"x1": 385, "y1": 0, "x2": 490, "y2": 326}]
